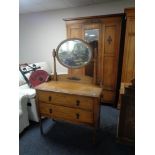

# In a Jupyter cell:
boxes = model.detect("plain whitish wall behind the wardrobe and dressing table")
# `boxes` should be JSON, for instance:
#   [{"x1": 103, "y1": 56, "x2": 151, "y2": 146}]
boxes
[{"x1": 19, "y1": 0, "x2": 134, "y2": 73}]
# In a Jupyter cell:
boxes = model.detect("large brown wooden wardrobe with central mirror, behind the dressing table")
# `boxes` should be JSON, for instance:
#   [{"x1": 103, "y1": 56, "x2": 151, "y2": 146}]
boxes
[{"x1": 64, "y1": 14, "x2": 124, "y2": 105}]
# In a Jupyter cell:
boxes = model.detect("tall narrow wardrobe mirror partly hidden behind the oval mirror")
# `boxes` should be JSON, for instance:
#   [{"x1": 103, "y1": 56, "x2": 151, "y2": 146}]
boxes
[{"x1": 85, "y1": 29, "x2": 99, "y2": 77}]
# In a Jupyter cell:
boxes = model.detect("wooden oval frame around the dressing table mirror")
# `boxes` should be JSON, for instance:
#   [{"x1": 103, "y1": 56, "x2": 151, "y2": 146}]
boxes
[{"x1": 56, "y1": 38, "x2": 93, "y2": 69}]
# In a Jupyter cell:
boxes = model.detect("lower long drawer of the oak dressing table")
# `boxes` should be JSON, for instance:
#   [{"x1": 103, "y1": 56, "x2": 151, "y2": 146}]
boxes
[{"x1": 39, "y1": 102, "x2": 93, "y2": 123}]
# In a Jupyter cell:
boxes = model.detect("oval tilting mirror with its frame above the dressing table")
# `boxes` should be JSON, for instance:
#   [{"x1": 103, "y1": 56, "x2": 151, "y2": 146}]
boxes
[{"x1": 56, "y1": 38, "x2": 92, "y2": 68}]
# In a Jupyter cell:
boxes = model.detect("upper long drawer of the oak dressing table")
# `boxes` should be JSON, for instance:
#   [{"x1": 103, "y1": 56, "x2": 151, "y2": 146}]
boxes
[{"x1": 38, "y1": 91, "x2": 94, "y2": 111}]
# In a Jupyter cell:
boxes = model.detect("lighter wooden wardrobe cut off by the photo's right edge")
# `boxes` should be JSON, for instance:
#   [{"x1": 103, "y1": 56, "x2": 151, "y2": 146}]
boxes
[{"x1": 118, "y1": 8, "x2": 135, "y2": 107}]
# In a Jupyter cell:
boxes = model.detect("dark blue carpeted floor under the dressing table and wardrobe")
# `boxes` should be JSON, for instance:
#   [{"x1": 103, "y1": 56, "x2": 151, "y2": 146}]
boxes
[{"x1": 19, "y1": 106, "x2": 135, "y2": 155}]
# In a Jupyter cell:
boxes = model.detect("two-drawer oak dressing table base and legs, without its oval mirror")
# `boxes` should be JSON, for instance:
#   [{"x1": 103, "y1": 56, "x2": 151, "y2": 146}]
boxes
[{"x1": 35, "y1": 38, "x2": 102, "y2": 142}]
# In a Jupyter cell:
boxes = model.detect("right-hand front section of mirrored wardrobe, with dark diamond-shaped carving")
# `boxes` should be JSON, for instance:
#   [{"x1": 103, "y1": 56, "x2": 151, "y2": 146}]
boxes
[{"x1": 101, "y1": 18, "x2": 121, "y2": 103}]
